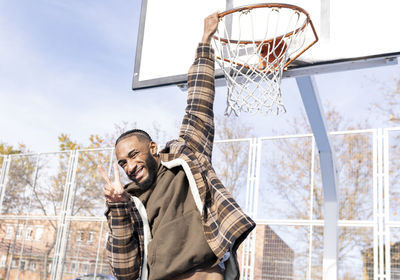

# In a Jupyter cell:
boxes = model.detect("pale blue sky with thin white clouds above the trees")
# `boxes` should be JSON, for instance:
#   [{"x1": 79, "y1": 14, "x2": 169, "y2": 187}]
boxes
[{"x1": 0, "y1": 0, "x2": 400, "y2": 152}]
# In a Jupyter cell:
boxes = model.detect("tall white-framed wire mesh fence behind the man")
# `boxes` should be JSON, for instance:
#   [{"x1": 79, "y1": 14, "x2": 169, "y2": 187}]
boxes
[{"x1": 0, "y1": 129, "x2": 400, "y2": 280}]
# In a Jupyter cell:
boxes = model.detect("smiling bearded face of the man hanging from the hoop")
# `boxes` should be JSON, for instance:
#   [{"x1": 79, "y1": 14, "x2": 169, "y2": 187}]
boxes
[{"x1": 115, "y1": 135, "x2": 158, "y2": 189}]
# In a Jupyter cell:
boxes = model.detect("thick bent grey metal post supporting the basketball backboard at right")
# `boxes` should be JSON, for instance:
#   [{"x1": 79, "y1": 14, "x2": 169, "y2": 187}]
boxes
[{"x1": 296, "y1": 76, "x2": 339, "y2": 280}]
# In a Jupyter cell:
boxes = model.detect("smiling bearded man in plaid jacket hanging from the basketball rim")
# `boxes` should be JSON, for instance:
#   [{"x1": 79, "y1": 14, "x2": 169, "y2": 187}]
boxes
[{"x1": 100, "y1": 13, "x2": 255, "y2": 280}]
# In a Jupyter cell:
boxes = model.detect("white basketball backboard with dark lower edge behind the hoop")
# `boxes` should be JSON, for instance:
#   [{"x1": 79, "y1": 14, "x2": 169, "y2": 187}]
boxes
[{"x1": 133, "y1": 0, "x2": 400, "y2": 90}]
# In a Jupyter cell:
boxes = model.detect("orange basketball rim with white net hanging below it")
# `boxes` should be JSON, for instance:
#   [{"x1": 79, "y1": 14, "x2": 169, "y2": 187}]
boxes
[{"x1": 213, "y1": 4, "x2": 318, "y2": 116}]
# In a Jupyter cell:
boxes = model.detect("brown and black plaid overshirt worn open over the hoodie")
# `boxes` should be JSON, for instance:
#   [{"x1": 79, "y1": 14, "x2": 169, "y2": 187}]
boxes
[{"x1": 106, "y1": 44, "x2": 255, "y2": 280}]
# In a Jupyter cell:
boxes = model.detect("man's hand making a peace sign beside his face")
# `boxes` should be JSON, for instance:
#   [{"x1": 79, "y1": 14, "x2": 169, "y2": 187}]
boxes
[{"x1": 98, "y1": 162, "x2": 130, "y2": 202}]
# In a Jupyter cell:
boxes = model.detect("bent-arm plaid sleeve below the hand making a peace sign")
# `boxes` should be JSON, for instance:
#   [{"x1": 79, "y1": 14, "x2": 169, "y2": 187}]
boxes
[{"x1": 105, "y1": 201, "x2": 143, "y2": 280}]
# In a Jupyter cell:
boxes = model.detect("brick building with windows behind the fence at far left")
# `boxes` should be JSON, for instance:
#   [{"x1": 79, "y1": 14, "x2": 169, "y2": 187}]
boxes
[{"x1": 0, "y1": 217, "x2": 111, "y2": 280}]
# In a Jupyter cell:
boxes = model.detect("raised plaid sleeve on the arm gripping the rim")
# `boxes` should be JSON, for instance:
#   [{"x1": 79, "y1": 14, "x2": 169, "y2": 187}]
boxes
[{"x1": 180, "y1": 43, "x2": 215, "y2": 159}]
